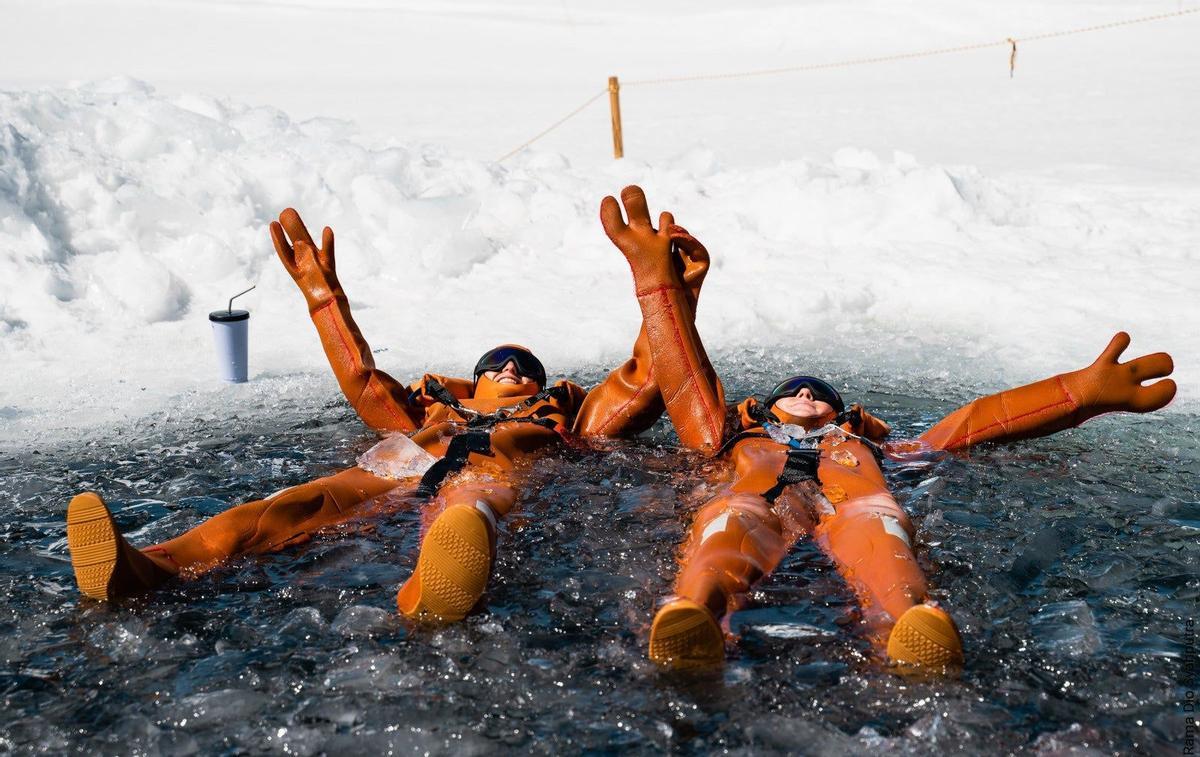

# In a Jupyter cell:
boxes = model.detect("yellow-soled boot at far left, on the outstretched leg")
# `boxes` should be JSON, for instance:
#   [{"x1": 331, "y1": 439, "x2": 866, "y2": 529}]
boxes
[{"x1": 67, "y1": 492, "x2": 174, "y2": 600}]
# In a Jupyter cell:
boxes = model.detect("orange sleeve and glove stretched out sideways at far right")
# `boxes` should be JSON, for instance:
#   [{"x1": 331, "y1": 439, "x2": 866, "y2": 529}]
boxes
[{"x1": 920, "y1": 331, "x2": 1176, "y2": 450}]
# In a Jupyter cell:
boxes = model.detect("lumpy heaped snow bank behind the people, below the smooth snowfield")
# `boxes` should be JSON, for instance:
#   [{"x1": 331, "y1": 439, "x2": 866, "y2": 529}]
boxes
[{"x1": 0, "y1": 78, "x2": 1200, "y2": 439}]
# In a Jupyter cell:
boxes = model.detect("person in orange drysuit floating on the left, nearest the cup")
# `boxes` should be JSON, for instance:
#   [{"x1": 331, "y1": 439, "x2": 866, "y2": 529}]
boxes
[{"x1": 67, "y1": 201, "x2": 708, "y2": 620}]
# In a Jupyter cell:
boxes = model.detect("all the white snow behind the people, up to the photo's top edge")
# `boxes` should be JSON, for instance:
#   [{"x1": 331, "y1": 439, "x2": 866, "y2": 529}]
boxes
[{"x1": 0, "y1": 0, "x2": 1200, "y2": 444}]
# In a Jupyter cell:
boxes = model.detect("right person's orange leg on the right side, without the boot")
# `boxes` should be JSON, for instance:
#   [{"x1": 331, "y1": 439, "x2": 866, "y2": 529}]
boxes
[{"x1": 816, "y1": 493, "x2": 925, "y2": 638}]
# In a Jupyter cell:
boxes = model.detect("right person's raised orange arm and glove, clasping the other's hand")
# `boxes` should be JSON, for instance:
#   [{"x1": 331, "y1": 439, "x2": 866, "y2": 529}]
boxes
[{"x1": 600, "y1": 186, "x2": 725, "y2": 452}]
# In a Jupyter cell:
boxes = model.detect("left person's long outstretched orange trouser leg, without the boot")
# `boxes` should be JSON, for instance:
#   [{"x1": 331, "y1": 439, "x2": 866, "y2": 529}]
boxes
[{"x1": 144, "y1": 468, "x2": 396, "y2": 571}]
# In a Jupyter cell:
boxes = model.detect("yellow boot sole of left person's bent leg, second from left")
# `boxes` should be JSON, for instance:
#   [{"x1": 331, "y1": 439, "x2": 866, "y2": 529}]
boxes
[{"x1": 396, "y1": 505, "x2": 492, "y2": 621}]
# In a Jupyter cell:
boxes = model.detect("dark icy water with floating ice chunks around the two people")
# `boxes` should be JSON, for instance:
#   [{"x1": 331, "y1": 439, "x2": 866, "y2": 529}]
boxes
[{"x1": 0, "y1": 355, "x2": 1200, "y2": 755}]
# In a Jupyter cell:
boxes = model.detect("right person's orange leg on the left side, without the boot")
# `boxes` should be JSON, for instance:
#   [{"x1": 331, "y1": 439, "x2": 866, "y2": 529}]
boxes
[{"x1": 676, "y1": 492, "x2": 794, "y2": 618}]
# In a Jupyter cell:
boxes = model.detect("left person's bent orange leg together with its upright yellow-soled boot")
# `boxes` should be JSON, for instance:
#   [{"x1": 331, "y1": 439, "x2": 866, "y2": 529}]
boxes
[{"x1": 396, "y1": 468, "x2": 516, "y2": 621}]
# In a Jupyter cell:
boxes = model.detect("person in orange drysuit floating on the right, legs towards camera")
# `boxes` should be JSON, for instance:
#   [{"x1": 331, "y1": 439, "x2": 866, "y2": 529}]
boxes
[{"x1": 600, "y1": 187, "x2": 1176, "y2": 669}]
